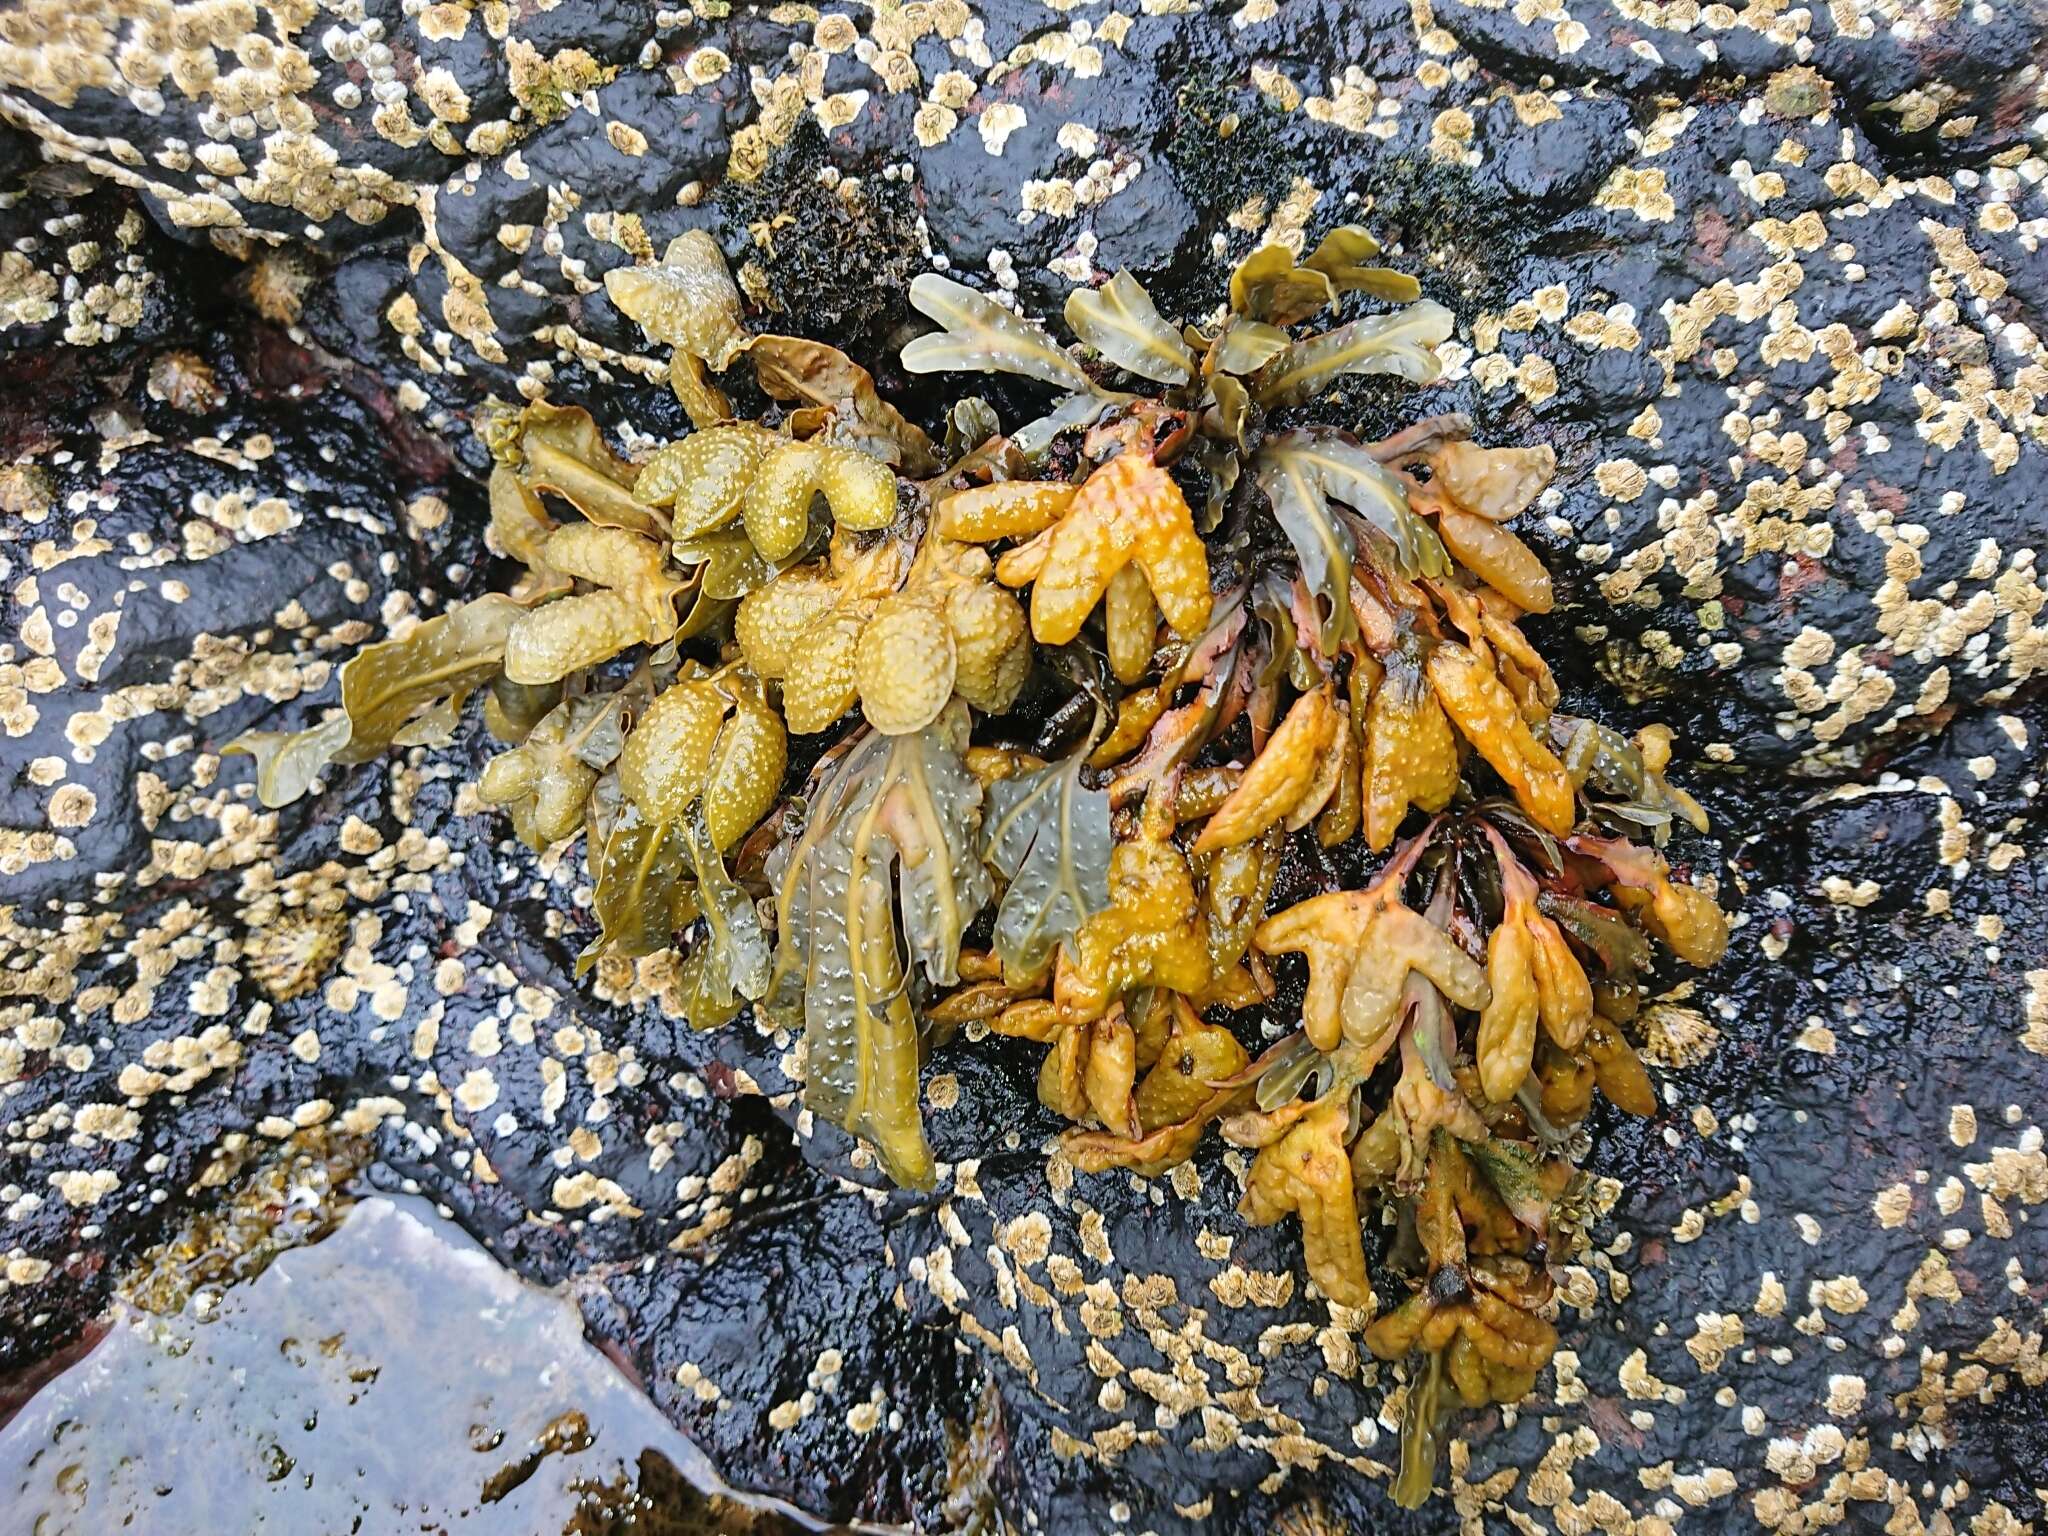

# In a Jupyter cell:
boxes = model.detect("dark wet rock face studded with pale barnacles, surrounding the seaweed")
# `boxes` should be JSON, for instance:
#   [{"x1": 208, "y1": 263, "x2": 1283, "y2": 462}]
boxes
[{"x1": 0, "y1": 0, "x2": 2048, "y2": 1530}]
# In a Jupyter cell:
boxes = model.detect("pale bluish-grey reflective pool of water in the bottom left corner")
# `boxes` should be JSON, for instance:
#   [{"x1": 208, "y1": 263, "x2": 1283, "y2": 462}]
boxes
[{"x1": 0, "y1": 1200, "x2": 806, "y2": 1532}]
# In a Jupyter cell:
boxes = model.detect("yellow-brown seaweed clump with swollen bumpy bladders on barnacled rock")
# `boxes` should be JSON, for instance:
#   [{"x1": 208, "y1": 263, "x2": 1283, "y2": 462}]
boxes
[{"x1": 240, "y1": 227, "x2": 1726, "y2": 1501}]
